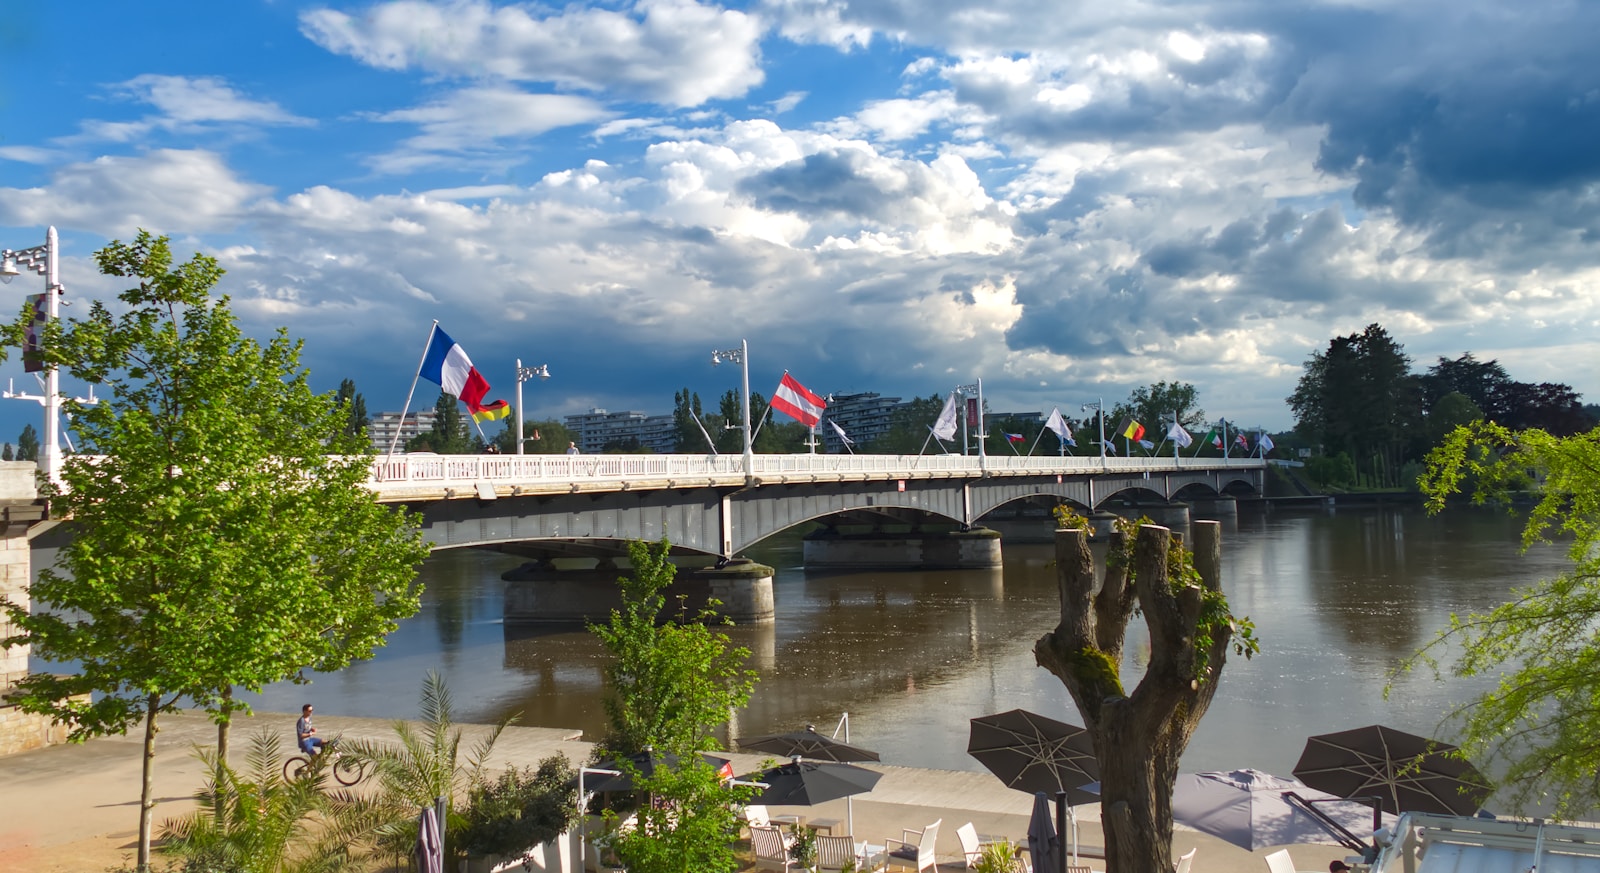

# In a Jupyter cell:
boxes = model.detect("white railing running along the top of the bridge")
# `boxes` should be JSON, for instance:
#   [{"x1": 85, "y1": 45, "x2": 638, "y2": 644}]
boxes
[{"x1": 371, "y1": 454, "x2": 1266, "y2": 491}]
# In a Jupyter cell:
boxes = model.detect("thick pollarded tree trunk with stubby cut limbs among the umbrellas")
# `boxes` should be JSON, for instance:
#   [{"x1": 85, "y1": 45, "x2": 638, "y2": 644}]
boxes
[{"x1": 1034, "y1": 521, "x2": 1232, "y2": 873}]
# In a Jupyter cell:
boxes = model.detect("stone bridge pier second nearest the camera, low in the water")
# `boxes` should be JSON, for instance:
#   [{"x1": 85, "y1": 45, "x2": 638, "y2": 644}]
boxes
[{"x1": 802, "y1": 528, "x2": 1000, "y2": 569}]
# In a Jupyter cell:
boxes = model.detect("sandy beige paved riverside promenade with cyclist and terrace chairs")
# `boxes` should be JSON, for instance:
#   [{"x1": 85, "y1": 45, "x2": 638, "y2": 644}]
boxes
[{"x1": 0, "y1": 713, "x2": 1347, "y2": 873}]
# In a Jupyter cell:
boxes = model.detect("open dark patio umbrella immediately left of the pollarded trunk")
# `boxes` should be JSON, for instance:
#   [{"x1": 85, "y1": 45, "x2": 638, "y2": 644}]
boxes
[{"x1": 966, "y1": 710, "x2": 1099, "y2": 804}]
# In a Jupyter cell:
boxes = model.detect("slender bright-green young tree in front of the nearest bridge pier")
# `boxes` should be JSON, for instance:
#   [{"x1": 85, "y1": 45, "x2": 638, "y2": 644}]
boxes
[{"x1": 589, "y1": 539, "x2": 755, "y2": 756}]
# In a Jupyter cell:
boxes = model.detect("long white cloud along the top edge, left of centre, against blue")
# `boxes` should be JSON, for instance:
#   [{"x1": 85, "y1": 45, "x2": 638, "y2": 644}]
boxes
[{"x1": 301, "y1": 0, "x2": 763, "y2": 106}]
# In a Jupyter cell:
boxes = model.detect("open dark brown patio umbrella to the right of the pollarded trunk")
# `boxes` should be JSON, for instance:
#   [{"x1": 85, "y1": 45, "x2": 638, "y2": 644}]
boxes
[{"x1": 1294, "y1": 724, "x2": 1493, "y2": 815}]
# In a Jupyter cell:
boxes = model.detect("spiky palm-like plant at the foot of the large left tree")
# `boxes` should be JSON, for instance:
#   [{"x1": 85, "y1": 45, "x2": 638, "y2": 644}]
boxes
[{"x1": 160, "y1": 729, "x2": 350, "y2": 873}]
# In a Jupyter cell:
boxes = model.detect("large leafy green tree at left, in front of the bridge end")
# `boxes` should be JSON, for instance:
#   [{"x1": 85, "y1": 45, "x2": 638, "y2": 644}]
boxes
[{"x1": 0, "y1": 232, "x2": 427, "y2": 868}]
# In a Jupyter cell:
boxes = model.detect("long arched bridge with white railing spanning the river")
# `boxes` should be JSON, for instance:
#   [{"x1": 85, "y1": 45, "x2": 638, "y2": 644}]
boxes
[{"x1": 370, "y1": 454, "x2": 1266, "y2": 558}]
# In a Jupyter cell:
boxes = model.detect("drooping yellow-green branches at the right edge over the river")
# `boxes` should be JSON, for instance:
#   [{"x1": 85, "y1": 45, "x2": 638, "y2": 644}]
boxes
[{"x1": 1406, "y1": 422, "x2": 1600, "y2": 819}]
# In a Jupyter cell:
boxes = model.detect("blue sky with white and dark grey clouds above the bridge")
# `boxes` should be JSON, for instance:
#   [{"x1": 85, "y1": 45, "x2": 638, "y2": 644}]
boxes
[{"x1": 0, "y1": 0, "x2": 1600, "y2": 440}]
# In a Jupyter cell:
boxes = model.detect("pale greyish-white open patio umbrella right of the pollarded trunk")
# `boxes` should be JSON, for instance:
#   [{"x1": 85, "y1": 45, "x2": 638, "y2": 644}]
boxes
[{"x1": 1173, "y1": 769, "x2": 1395, "y2": 852}]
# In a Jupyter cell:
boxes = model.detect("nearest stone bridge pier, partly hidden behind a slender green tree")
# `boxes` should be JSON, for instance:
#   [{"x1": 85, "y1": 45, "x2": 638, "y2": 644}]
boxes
[{"x1": 501, "y1": 560, "x2": 774, "y2": 624}]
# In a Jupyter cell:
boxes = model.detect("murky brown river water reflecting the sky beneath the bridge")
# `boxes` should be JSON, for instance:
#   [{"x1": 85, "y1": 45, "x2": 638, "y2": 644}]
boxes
[{"x1": 243, "y1": 505, "x2": 1565, "y2": 774}]
